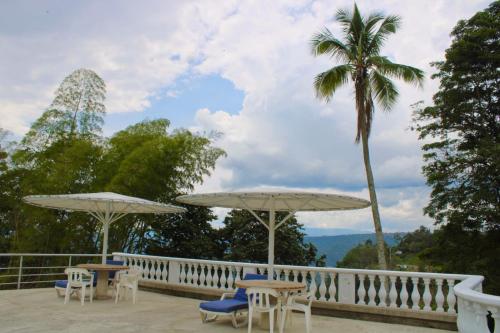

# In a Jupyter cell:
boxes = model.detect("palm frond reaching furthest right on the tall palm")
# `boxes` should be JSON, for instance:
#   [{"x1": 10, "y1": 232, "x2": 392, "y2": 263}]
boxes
[{"x1": 368, "y1": 56, "x2": 424, "y2": 87}]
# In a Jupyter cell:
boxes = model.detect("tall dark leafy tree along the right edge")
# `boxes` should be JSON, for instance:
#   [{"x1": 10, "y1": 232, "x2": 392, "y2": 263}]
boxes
[{"x1": 415, "y1": 1, "x2": 500, "y2": 293}]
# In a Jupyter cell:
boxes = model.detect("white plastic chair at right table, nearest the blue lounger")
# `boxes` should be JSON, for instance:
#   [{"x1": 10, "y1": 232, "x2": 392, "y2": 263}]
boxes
[{"x1": 247, "y1": 288, "x2": 279, "y2": 333}]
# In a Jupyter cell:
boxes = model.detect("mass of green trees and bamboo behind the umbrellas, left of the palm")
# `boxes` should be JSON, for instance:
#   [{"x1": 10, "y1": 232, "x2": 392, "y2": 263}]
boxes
[{"x1": 0, "y1": 69, "x2": 324, "y2": 272}]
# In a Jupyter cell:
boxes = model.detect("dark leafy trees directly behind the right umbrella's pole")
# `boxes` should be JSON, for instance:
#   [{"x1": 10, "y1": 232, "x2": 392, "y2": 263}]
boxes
[{"x1": 221, "y1": 209, "x2": 326, "y2": 266}]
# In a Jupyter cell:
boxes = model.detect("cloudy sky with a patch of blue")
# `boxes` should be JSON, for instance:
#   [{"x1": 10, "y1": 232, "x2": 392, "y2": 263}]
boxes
[{"x1": 0, "y1": 0, "x2": 489, "y2": 234}]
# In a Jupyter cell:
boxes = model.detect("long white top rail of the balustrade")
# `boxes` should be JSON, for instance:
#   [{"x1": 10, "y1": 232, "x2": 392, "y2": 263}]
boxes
[{"x1": 113, "y1": 252, "x2": 474, "y2": 280}]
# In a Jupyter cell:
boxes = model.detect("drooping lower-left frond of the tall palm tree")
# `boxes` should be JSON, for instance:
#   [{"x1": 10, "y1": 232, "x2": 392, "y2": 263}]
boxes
[{"x1": 314, "y1": 64, "x2": 353, "y2": 102}]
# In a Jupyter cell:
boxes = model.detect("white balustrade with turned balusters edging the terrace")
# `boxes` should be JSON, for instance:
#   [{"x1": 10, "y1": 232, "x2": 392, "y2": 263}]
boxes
[{"x1": 113, "y1": 253, "x2": 500, "y2": 333}]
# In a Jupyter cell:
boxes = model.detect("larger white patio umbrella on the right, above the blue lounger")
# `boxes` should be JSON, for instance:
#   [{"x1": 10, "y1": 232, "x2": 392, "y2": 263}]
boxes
[{"x1": 177, "y1": 192, "x2": 370, "y2": 280}]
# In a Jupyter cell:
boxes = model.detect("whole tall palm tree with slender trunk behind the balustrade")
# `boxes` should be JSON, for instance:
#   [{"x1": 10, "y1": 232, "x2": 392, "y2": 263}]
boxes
[{"x1": 311, "y1": 4, "x2": 424, "y2": 269}]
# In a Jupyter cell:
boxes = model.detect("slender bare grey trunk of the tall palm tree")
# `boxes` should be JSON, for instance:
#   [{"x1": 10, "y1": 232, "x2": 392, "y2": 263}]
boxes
[{"x1": 361, "y1": 126, "x2": 387, "y2": 270}]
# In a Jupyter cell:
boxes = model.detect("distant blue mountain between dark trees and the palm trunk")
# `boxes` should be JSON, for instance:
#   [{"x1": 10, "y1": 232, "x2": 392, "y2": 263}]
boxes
[{"x1": 305, "y1": 233, "x2": 397, "y2": 267}]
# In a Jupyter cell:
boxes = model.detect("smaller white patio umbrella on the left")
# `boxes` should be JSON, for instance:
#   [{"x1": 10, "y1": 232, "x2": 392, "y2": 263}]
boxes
[{"x1": 23, "y1": 192, "x2": 186, "y2": 264}]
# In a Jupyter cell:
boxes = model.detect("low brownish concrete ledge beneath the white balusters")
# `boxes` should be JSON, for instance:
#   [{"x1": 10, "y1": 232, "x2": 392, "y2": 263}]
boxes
[{"x1": 139, "y1": 281, "x2": 457, "y2": 331}]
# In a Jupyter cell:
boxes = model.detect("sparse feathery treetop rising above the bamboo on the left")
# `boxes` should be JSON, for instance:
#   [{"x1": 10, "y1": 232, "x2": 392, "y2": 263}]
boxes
[{"x1": 23, "y1": 69, "x2": 106, "y2": 150}]
